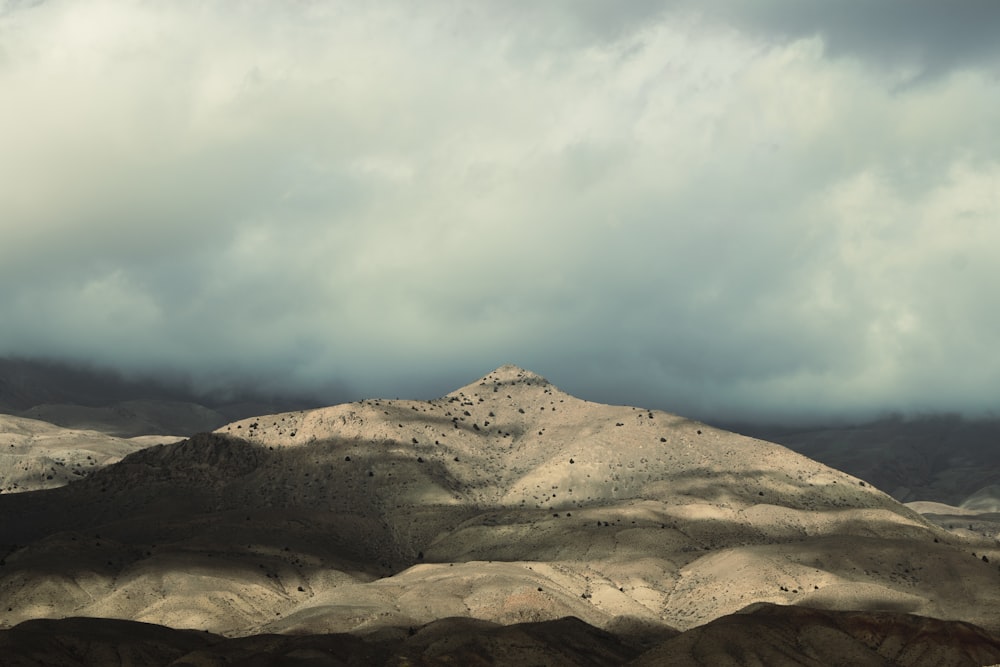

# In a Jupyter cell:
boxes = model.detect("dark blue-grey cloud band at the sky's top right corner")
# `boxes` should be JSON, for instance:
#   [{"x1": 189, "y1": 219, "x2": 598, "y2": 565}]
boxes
[{"x1": 518, "y1": 0, "x2": 1000, "y2": 77}]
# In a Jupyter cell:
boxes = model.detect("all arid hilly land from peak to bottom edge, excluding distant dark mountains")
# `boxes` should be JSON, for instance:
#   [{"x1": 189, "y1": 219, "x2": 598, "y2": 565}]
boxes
[{"x1": 0, "y1": 366, "x2": 1000, "y2": 665}]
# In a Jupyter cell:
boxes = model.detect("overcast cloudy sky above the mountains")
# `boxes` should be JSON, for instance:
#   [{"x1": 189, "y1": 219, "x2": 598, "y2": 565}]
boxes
[{"x1": 0, "y1": 0, "x2": 1000, "y2": 419}]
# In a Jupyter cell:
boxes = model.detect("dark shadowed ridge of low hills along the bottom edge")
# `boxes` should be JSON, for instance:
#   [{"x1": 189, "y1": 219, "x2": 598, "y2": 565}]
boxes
[{"x1": 0, "y1": 604, "x2": 1000, "y2": 667}]
